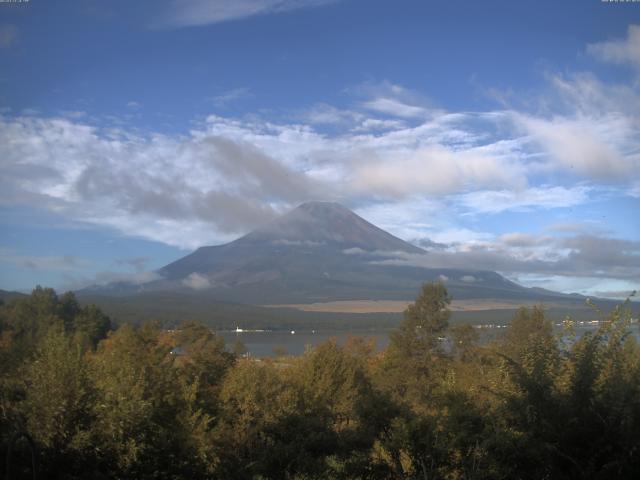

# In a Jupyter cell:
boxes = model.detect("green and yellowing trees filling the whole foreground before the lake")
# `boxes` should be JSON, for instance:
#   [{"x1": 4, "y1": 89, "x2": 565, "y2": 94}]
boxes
[{"x1": 0, "y1": 283, "x2": 640, "y2": 480}]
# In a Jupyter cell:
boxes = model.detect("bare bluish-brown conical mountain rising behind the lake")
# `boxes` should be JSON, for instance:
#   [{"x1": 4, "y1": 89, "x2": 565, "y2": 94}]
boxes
[{"x1": 85, "y1": 202, "x2": 575, "y2": 305}]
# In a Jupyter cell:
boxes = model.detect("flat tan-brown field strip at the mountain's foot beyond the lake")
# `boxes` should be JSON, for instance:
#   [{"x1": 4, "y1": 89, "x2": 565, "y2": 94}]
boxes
[{"x1": 262, "y1": 299, "x2": 535, "y2": 313}]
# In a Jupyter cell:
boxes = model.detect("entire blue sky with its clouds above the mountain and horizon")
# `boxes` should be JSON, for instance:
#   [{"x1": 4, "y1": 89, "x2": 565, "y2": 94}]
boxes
[{"x1": 0, "y1": 0, "x2": 640, "y2": 297}]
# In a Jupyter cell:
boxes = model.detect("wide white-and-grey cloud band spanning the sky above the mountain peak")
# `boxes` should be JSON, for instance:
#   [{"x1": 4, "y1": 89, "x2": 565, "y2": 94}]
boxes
[{"x1": 0, "y1": 55, "x2": 640, "y2": 255}]
